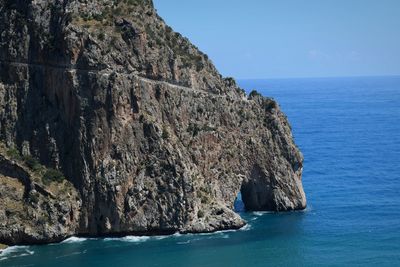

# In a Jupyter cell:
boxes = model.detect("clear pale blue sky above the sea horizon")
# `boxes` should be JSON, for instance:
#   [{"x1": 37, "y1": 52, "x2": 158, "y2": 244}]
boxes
[{"x1": 154, "y1": 0, "x2": 400, "y2": 79}]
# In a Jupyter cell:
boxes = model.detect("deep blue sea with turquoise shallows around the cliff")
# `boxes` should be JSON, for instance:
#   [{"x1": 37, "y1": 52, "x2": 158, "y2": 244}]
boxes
[{"x1": 0, "y1": 77, "x2": 400, "y2": 267}]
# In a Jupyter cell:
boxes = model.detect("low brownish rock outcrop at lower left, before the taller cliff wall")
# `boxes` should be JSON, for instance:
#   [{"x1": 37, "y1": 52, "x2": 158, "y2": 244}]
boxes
[{"x1": 0, "y1": 143, "x2": 81, "y2": 244}]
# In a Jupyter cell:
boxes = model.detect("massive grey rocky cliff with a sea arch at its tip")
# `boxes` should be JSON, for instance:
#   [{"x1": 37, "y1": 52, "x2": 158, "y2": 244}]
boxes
[{"x1": 0, "y1": 0, "x2": 306, "y2": 244}]
